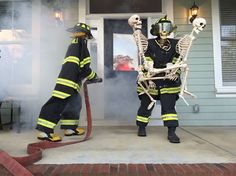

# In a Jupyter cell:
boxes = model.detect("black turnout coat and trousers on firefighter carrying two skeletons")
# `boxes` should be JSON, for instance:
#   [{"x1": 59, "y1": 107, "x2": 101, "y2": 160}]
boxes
[{"x1": 136, "y1": 38, "x2": 181, "y2": 126}]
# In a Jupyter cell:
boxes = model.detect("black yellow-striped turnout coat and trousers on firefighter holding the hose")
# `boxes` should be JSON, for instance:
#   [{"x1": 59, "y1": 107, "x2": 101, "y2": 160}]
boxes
[{"x1": 36, "y1": 38, "x2": 97, "y2": 133}]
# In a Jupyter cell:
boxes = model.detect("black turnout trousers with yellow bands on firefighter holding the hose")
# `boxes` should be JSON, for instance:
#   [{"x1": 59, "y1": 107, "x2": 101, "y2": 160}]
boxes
[{"x1": 36, "y1": 93, "x2": 82, "y2": 133}]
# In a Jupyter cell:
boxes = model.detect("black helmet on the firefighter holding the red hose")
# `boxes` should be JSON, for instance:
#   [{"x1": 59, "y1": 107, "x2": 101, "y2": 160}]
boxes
[{"x1": 67, "y1": 23, "x2": 93, "y2": 39}]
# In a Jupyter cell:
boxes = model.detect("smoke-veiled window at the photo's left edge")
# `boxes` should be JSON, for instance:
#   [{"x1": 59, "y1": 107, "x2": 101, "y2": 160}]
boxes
[{"x1": 0, "y1": 0, "x2": 32, "y2": 98}]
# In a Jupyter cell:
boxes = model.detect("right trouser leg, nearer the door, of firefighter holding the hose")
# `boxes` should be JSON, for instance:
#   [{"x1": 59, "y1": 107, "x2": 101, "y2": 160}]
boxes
[{"x1": 61, "y1": 93, "x2": 82, "y2": 129}]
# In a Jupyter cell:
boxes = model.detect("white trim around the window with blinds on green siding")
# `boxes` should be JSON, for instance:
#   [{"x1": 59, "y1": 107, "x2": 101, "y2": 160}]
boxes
[{"x1": 211, "y1": 0, "x2": 236, "y2": 97}]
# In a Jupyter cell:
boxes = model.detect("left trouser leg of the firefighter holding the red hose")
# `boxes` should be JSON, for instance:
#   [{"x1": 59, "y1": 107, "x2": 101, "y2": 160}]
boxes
[{"x1": 36, "y1": 97, "x2": 68, "y2": 133}]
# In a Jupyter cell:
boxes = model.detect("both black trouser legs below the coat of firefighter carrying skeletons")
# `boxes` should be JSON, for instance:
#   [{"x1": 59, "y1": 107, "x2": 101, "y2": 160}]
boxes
[{"x1": 136, "y1": 93, "x2": 179, "y2": 127}]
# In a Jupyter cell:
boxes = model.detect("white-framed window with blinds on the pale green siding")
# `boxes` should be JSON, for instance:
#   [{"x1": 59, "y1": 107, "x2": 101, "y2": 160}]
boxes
[{"x1": 212, "y1": 0, "x2": 236, "y2": 96}]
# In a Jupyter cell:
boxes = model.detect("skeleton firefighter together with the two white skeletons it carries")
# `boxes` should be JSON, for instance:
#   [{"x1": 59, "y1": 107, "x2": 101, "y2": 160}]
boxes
[{"x1": 129, "y1": 16, "x2": 206, "y2": 143}]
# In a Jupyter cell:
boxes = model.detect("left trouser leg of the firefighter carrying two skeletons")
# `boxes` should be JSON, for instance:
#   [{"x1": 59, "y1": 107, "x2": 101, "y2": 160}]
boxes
[{"x1": 136, "y1": 94, "x2": 154, "y2": 126}]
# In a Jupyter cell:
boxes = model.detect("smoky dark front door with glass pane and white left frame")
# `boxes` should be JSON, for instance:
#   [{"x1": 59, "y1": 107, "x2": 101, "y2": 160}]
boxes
[{"x1": 86, "y1": 17, "x2": 162, "y2": 125}]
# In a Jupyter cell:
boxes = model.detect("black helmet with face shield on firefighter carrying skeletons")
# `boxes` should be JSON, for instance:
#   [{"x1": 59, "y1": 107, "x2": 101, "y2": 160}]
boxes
[{"x1": 150, "y1": 16, "x2": 176, "y2": 36}]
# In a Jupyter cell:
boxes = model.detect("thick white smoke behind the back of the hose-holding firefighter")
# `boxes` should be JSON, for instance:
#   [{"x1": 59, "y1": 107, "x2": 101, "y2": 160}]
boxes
[{"x1": 0, "y1": 1, "x2": 70, "y2": 128}]
